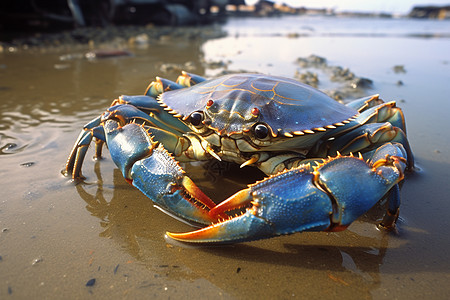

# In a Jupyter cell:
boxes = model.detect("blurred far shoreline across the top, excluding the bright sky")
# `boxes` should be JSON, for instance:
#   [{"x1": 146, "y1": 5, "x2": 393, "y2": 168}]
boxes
[{"x1": 6, "y1": 0, "x2": 450, "y2": 30}]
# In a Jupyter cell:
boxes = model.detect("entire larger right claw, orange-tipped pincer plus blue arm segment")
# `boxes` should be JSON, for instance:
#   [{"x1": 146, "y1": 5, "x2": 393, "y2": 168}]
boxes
[{"x1": 167, "y1": 144, "x2": 406, "y2": 243}]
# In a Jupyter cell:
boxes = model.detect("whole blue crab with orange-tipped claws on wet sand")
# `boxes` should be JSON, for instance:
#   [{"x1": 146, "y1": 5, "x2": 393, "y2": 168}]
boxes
[{"x1": 64, "y1": 72, "x2": 414, "y2": 243}]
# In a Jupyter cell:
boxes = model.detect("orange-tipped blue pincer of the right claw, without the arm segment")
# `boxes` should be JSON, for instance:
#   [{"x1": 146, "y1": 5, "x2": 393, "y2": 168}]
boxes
[{"x1": 167, "y1": 167, "x2": 332, "y2": 243}]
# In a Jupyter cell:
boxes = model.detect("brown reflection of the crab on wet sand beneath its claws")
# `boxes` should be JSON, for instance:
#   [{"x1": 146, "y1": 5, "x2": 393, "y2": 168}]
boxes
[{"x1": 76, "y1": 157, "x2": 408, "y2": 297}]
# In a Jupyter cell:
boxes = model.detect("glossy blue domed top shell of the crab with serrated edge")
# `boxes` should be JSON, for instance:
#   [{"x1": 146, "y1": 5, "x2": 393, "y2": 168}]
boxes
[{"x1": 158, "y1": 74, "x2": 358, "y2": 136}]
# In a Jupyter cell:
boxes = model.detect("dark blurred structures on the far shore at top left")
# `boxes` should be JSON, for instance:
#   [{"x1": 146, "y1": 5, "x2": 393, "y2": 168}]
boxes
[{"x1": 0, "y1": 0, "x2": 239, "y2": 28}]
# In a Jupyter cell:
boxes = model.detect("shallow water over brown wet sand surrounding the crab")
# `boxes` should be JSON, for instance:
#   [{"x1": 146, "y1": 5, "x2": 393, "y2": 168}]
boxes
[{"x1": 0, "y1": 17, "x2": 450, "y2": 299}]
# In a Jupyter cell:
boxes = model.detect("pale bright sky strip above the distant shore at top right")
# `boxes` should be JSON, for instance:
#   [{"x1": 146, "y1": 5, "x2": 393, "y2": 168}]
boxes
[{"x1": 246, "y1": 0, "x2": 450, "y2": 14}]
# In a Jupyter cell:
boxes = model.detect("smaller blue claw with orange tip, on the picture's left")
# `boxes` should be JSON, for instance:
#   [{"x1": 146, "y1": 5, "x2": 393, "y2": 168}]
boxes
[{"x1": 104, "y1": 120, "x2": 220, "y2": 225}]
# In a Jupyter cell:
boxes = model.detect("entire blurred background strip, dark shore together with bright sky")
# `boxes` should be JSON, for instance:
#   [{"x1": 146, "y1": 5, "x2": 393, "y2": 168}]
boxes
[{"x1": 0, "y1": 0, "x2": 448, "y2": 28}]
